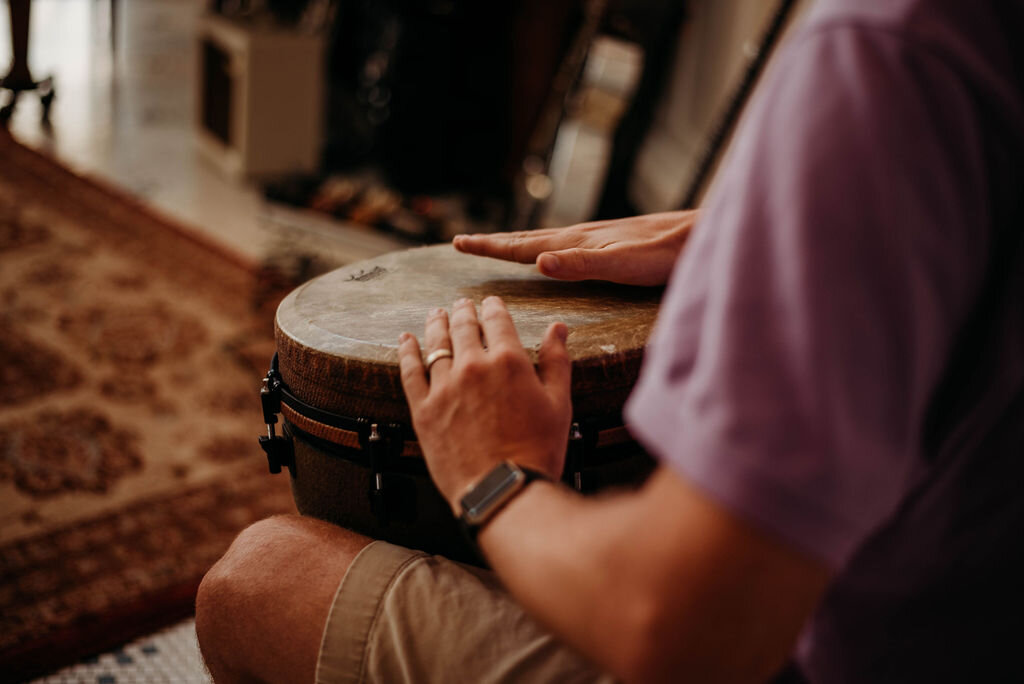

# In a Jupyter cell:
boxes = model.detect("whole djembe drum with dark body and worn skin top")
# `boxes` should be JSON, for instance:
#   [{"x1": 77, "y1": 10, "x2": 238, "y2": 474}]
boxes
[{"x1": 260, "y1": 245, "x2": 662, "y2": 561}]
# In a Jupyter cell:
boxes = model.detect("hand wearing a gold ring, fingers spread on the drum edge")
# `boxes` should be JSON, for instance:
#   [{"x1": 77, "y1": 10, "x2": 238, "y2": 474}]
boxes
[{"x1": 398, "y1": 297, "x2": 572, "y2": 513}]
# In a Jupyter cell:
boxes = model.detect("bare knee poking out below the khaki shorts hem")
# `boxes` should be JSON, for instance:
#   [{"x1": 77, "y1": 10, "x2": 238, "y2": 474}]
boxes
[{"x1": 196, "y1": 516, "x2": 372, "y2": 683}]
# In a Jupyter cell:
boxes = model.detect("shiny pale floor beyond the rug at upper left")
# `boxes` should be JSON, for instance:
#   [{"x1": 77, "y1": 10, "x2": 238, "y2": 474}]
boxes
[{"x1": 0, "y1": 0, "x2": 401, "y2": 265}]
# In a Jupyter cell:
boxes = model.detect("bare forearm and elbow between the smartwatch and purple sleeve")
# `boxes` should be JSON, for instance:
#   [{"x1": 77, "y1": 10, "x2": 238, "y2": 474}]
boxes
[{"x1": 480, "y1": 470, "x2": 828, "y2": 682}]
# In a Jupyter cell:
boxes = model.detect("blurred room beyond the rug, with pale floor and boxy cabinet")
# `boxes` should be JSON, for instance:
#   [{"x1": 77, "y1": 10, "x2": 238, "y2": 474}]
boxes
[{"x1": 0, "y1": 0, "x2": 799, "y2": 278}]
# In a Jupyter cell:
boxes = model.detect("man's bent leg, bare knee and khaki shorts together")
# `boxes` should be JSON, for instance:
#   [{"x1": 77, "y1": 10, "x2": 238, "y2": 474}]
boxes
[{"x1": 196, "y1": 516, "x2": 611, "y2": 684}]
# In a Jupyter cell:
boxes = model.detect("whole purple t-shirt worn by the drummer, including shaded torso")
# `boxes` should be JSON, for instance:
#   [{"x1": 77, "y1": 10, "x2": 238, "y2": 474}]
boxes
[{"x1": 627, "y1": 0, "x2": 1024, "y2": 683}]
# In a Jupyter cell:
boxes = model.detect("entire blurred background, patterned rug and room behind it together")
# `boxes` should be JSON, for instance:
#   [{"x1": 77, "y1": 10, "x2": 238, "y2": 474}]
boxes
[{"x1": 0, "y1": 0, "x2": 810, "y2": 683}]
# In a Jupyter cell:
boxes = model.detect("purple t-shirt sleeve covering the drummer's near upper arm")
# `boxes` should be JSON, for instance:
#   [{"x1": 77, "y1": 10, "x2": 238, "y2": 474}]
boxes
[{"x1": 627, "y1": 26, "x2": 990, "y2": 567}]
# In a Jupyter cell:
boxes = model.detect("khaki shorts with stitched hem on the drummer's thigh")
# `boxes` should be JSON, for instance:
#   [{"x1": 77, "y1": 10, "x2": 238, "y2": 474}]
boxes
[{"x1": 316, "y1": 542, "x2": 614, "y2": 684}]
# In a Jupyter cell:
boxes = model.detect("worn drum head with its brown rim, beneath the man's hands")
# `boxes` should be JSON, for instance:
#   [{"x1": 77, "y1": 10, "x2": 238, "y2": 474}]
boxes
[{"x1": 275, "y1": 245, "x2": 662, "y2": 423}]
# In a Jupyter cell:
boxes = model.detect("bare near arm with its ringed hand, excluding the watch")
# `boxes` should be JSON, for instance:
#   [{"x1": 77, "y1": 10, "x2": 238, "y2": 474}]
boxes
[{"x1": 398, "y1": 297, "x2": 828, "y2": 682}]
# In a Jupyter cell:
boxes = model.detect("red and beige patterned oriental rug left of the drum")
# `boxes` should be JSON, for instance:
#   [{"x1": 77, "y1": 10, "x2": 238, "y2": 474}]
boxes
[{"x1": 0, "y1": 131, "x2": 294, "y2": 681}]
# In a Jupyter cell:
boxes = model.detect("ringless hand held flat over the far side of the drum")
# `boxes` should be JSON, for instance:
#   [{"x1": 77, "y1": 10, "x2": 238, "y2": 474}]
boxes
[{"x1": 453, "y1": 210, "x2": 698, "y2": 286}]
